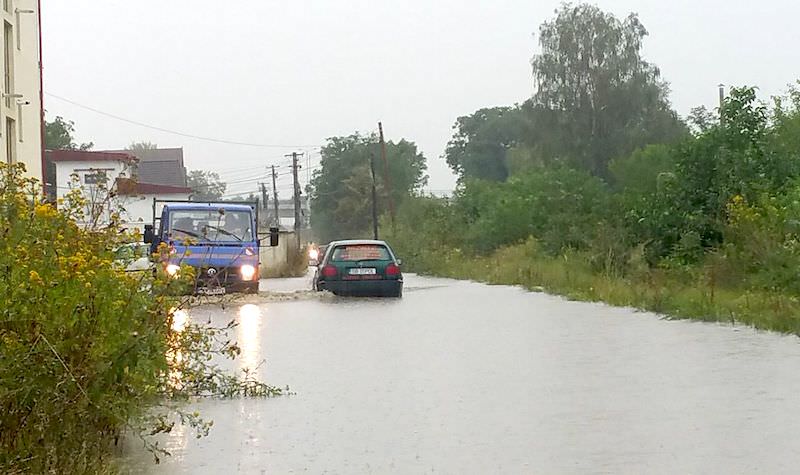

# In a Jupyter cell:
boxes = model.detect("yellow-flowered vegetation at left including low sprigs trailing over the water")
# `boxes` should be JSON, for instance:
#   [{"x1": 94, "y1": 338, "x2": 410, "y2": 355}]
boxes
[{"x1": 0, "y1": 164, "x2": 284, "y2": 473}]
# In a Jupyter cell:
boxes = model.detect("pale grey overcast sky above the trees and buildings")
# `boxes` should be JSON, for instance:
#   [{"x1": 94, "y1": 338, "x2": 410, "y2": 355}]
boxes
[{"x1": 42, "y1": 0, "x2": 800, "y2": 196}]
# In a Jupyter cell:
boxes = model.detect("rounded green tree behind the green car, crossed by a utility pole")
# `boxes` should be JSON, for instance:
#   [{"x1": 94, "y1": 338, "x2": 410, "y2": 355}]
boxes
[{"x1": 308, "y1": 134, "x2": 427, "y2": 242}]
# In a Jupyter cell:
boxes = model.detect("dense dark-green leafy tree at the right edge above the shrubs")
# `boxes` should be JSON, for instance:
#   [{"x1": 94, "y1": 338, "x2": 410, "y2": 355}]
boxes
[{"x1": 627, "y1": 88, "x2": 800, "y2": 262}]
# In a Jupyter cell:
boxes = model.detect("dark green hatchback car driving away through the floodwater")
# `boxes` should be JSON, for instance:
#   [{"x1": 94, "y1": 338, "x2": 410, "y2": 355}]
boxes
[{"x1": 314, "y1": 240, "x2": 403, "y2": 297}]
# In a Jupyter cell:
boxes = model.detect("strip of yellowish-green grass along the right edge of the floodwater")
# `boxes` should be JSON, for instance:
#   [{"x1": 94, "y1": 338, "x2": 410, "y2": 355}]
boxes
[{"x1": 406, "y1": 243, "x2": 800, "y2": 335}]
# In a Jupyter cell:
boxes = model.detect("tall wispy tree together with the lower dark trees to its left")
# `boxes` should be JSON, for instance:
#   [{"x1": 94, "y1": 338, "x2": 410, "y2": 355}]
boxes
[{"x1": 445, "y1": 4, "x2": 688, "y2": 181}]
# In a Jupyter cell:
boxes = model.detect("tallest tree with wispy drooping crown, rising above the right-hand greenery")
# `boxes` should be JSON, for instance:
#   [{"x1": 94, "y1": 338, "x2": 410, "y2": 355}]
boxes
[{"x1": 531, "y1": 4, "x2": 686, "y2": 177}]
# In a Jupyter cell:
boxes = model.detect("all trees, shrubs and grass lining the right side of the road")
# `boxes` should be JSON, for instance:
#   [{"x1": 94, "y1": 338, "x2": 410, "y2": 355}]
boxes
[{"x1": 310, "y1": 4, "x2": 800, "y2": 334}]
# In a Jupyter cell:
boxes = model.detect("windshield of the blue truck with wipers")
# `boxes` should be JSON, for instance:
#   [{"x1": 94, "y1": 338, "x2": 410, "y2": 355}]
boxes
[{"x1": 169, "y1": 209, "x2": 253, "y2": 242}]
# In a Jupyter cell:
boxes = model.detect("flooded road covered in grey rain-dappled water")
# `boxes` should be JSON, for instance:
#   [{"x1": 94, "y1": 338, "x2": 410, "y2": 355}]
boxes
[{"x1": 128, "y1": 275, "x2": 800, "y2": 474}]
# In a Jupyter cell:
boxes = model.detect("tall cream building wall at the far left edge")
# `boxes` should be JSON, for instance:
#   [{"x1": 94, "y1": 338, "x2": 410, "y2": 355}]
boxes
[{"x1": 0, "y1": 0, "x2": 43, "y2": 180}]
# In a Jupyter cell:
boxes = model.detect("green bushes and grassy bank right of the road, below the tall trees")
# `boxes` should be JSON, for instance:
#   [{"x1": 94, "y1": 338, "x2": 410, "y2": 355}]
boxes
[{"x1": 389, "y1": 77, "x2": 800, "y2": 334}]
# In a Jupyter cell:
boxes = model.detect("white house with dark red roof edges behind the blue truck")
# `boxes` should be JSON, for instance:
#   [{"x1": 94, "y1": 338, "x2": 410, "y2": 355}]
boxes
[{"x1": 46, "y1": 150, "x2": 191, "y2": 231}]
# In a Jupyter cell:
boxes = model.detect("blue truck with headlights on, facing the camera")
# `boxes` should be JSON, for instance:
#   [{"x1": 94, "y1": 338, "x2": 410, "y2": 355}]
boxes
[{"x1": 144, "y1": 200, "x2": 278, "y2": 295}]
